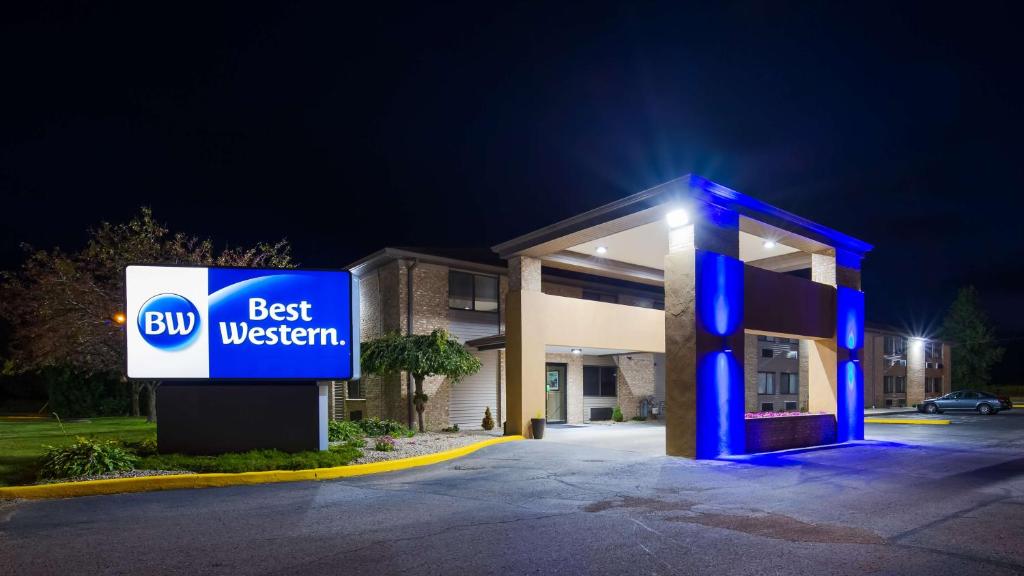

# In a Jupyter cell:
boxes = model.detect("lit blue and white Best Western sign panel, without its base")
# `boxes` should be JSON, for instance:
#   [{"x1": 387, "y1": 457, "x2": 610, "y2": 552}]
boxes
[{"x1": 125, "y1": 266, "x2": 358, "y2": 380}]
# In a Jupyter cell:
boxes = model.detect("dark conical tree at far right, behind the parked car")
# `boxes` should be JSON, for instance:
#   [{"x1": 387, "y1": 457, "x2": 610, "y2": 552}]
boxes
[{"x1": 942, "y1": 286, "x2": 1006, "y2": 388}]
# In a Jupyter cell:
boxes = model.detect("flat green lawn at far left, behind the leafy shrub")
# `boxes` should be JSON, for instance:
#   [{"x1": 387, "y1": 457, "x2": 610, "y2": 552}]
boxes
[{"x1": 0, "y1": 417, "x2": 157, "y2": 486}]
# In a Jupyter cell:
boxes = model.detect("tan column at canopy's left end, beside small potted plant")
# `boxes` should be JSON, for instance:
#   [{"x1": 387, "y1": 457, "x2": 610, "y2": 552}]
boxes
[{"x1": 505, "y1": 256, "x2": 545, "y2": 436}]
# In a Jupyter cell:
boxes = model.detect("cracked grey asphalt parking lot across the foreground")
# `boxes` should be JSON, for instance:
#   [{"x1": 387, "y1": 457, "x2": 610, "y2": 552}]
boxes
[{"x1": 0, "y1": 410, "x2": 1024, "y2": 575}]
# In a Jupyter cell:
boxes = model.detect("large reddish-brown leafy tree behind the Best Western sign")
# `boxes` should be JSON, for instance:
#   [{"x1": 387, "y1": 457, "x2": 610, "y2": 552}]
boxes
[{"x1": 0, "y1": 208, "x2": 294, "y2": 421}]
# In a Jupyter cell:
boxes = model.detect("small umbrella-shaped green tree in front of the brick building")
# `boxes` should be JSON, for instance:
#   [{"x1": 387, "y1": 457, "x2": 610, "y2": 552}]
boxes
[{"x1": 359, "y1": 330, "x2": 480, "y2": 431}]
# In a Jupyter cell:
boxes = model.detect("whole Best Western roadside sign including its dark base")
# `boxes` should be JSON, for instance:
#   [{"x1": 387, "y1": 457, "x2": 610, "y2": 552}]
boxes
[{"x1": 125, "y1": 265, "x2": 359, "y2": 453}]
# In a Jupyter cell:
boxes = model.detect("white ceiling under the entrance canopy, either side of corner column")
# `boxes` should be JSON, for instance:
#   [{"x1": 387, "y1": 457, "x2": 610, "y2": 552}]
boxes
[{"x1": 569, "y1": 220, "x2": 798, "y2": 270}]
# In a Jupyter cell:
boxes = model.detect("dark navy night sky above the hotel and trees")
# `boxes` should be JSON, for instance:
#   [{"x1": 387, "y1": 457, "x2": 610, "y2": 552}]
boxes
[{"x1": 0, "y1": 2, "x2": 1024, "y2": 373}]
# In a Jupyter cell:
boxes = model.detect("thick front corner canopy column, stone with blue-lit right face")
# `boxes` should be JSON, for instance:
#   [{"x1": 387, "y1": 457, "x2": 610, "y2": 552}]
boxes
[{"x1": 665, "y1": 205, "x2": 745, "y2": 458}]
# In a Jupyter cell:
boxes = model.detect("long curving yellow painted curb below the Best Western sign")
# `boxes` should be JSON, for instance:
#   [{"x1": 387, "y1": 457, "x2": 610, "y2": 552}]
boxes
[{"x1": 0, "y1": 436, "x2": 523, "y2": 499}]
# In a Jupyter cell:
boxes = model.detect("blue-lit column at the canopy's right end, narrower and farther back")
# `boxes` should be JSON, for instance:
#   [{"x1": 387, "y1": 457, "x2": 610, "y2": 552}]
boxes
[{"x1": 836, "y1": 251, "x2": 864, "y2": 442}]
